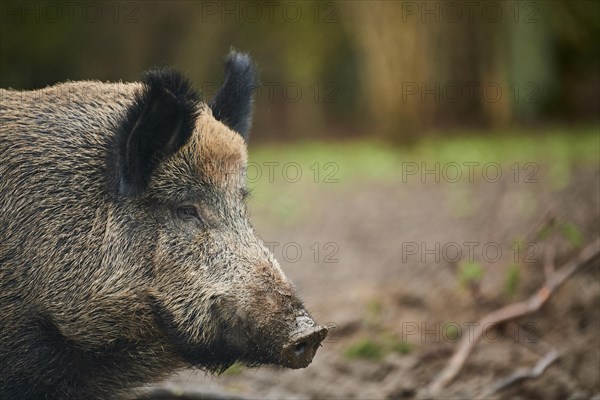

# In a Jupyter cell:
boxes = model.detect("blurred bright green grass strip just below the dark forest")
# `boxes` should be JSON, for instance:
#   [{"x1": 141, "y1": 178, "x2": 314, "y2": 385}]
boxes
[{"x1": 249, "y1": 126, "x2": 600, "y2": 185}]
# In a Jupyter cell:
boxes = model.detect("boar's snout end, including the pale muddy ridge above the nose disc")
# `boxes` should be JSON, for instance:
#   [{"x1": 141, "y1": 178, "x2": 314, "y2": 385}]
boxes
[{"x1": 281, "y1": 315, "x2": 328, "y2": 369}]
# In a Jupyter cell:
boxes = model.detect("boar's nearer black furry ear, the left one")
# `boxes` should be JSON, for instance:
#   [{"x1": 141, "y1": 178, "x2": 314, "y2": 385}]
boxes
[{"x1": 111, "y1": 69, "x2": 199, "y2": 197}]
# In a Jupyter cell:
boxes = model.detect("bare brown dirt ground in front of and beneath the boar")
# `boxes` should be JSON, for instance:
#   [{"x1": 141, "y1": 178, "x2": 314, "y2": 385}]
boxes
[{"x1": 157, "y1": 163, "x2": 600, "y2": 399}]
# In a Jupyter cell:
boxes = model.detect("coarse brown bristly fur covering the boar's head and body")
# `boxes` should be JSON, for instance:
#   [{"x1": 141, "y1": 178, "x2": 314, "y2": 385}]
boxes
[{"x1": 0, "y1": 54, "x2": 326, "y2": 399}]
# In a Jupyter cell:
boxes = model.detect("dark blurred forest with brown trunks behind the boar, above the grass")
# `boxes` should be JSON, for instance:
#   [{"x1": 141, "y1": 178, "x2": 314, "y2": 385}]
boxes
[{"x1": 0, "y1": 0, "x2": 600, "y2": 141}]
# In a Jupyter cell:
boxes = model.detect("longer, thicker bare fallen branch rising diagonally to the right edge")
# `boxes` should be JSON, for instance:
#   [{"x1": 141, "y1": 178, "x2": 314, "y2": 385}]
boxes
[{"x1": 428, "y1": 239, "x2": 600, "y2": 396}]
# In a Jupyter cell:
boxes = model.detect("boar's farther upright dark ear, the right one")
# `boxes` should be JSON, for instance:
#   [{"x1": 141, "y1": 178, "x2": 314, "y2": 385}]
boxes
[{"x1": 209, "y1": 51, "x2": 257, "y2": 141}]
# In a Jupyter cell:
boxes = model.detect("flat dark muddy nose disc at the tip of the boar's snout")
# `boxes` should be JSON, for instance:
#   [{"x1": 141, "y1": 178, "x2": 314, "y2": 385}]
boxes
[{"x1": 281, "y1": 326, "x2": 328, "y2": 369}]
